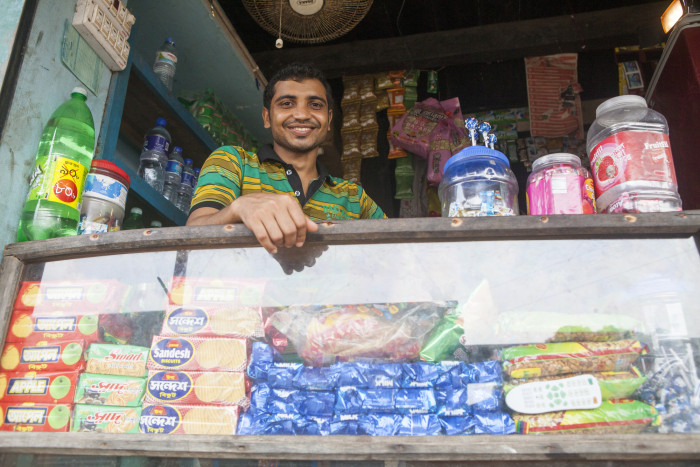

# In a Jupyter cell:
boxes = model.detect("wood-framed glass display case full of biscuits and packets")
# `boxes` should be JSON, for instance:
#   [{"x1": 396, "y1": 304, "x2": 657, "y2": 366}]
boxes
[{"x1": 0, "y1": 215, "x2": 700, "y2": 462}]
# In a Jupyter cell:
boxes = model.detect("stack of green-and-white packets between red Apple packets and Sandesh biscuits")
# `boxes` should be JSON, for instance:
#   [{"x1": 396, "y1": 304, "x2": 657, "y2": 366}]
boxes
[{"x1": 71, "y1": 343, "x2": 148, "y2": 433}]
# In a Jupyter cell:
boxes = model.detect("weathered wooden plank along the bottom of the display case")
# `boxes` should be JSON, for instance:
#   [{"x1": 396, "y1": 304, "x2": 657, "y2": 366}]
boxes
[{"x1": 0, "y1": 432, "x2": 700, "y2": 463}]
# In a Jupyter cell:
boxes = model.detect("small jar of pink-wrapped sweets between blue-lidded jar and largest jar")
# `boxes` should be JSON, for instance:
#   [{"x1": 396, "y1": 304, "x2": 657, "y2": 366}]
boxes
[{"x1": 526, "y1": 152, "x2": 595, "y2": 216}]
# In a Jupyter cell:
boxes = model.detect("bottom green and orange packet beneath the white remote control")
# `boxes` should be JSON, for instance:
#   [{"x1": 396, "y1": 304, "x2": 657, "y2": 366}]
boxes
[{"x1": 513, "y1": 399, "x2": 658, "y2": 434}]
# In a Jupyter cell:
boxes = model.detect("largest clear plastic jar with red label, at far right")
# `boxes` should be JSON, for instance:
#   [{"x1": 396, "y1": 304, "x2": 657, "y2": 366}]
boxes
[{"x1": 586, "y1": 95, "x2": 681, "y2": 213}]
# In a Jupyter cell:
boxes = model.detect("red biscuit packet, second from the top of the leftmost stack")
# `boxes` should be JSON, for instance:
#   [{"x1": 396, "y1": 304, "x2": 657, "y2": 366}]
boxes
[{"x1": 6, "y1": 311, "x2": 99, "y2": 345}]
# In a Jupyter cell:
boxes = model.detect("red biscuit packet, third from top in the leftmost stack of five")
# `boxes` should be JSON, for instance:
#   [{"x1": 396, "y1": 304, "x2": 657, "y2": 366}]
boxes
[{"x1": 0, "y1": 340, "x2": 85, "y2": 372}]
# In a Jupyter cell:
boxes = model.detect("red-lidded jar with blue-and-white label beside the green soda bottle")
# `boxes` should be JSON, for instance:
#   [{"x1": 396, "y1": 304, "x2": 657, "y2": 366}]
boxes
[{"x1": 78, "y1": 159, "x2": 131, "y2": 234}]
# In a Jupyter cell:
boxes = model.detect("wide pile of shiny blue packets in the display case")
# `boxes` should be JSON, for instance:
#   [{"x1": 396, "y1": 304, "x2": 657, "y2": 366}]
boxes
[{"x1": 238, "y1": 342, "x2": 515, "y2": 436}]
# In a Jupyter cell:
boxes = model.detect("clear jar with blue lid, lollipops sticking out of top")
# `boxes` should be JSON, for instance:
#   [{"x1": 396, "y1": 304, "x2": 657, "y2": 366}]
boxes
[{"x1": 438, "y1": 146, "x2": 519, "y2": 217}]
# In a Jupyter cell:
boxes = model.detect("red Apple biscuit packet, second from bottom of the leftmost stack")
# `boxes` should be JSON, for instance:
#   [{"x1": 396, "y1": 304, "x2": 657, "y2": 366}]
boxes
[{"x1": 0, "y1": 371, "x2": 79, "y2": 404}]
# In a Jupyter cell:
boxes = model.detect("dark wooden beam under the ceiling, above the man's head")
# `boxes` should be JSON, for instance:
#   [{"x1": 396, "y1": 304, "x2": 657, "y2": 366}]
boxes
[{"x1": 253, "y1": 2, "x2": 668, "y2": 78}]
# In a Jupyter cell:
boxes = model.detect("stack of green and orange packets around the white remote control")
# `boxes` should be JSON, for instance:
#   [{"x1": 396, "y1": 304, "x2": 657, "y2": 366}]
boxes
[{"x1": 501, "y1": 340, "x2": 660, "y2": 434}]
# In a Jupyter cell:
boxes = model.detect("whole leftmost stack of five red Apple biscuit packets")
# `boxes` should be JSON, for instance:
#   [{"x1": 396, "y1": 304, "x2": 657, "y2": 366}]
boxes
[{"x1": 0, "y1": 280, "x2": 125, "y2": 432}]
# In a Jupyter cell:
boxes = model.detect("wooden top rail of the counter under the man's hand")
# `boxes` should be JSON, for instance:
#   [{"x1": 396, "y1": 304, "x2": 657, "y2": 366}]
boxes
[{"x1": 5, "y1": 210, "x2": 700, "y2": 261}]
